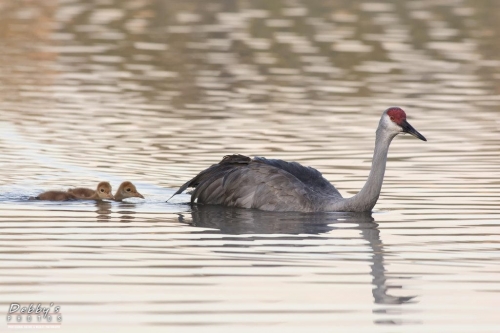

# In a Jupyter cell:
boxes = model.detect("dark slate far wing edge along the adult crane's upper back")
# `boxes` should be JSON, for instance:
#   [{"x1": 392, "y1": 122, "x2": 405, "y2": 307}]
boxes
[{"x1": 253, "y1": 157, "x2": 342, "y2": 198}]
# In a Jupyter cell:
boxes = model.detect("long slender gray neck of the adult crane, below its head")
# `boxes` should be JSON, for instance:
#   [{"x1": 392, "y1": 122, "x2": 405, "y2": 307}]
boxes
[{"x1": 331, "y1": 127, "x2": 396, "y2": 212}]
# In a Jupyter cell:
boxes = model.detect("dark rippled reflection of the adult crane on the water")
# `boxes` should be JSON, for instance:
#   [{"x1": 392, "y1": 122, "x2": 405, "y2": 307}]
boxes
[{"x1": 179, "y1": 205, "x2": 415, "y2": 304}]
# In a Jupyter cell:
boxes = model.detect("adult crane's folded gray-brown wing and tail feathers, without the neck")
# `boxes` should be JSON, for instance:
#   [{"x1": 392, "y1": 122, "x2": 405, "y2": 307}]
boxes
[{"x1": 171, "y1": 155, "x2": 340, "y2": 211}]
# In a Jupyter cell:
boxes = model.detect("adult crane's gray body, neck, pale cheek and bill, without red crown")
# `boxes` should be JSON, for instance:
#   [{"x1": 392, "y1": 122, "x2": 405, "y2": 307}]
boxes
[{"x1": 174, "y1": 111, "x2": 425, "y2": 212}]
